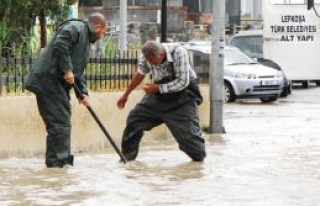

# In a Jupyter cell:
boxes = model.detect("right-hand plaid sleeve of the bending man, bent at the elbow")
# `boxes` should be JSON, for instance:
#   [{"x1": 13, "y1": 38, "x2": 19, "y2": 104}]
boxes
[{"x1": 159, "y1": 47, "x2": 190, "y2": 93}]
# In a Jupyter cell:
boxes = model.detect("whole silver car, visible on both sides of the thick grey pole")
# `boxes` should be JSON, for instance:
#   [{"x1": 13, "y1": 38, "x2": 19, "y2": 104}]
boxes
[{"x1": 184, "y1": 42, "x2": 284, "y2": 103}]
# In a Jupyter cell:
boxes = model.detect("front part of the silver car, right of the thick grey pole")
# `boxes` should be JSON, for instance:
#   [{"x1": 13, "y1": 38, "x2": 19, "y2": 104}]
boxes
[{"x1": 224, "y1": 47, "x2": 283, "y2": 102}]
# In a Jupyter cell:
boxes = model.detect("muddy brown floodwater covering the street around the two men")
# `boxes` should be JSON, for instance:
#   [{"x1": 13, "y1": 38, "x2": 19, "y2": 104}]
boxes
[{"x1": 0, "y1": 88, "x2": 320, "y2": 206}]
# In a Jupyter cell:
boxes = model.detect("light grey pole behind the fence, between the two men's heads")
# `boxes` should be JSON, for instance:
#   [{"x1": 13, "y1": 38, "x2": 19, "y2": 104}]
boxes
[{"x1": 119, "y1": 0, "x2": 128, "y2": 56}]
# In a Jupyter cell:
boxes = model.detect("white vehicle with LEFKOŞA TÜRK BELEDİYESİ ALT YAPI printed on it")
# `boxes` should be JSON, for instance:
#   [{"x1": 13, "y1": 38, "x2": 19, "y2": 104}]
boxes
[{"x1": 261, "y1": 0, "x2": 320, "y2": 88}]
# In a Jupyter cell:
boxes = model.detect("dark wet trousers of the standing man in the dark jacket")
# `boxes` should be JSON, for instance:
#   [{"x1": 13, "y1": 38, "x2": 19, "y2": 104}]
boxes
[{"x1": 36, "y1": 78, "x2": 73, "y2": 167}]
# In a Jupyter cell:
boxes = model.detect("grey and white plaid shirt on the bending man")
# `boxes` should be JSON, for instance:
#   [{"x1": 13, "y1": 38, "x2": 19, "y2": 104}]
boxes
[{"x1": 138, "y1": 44, "x2": 197, "y2": 94}]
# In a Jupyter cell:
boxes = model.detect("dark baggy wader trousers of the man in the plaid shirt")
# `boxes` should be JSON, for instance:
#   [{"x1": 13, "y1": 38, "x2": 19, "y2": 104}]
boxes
[{"x1": 121, "y1": 95, "x2": 206, "y2": 161}]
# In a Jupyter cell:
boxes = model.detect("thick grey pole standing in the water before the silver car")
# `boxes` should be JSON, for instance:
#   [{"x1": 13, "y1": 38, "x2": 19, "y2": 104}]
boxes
[{"x1": 209, "y1": 0, "x2": 226, "y2": 133}]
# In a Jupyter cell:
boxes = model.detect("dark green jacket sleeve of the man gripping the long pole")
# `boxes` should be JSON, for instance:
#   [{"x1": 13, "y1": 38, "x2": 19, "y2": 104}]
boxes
[{"x1": 52, "y1": 24, "x2": 79, "y2": 73}]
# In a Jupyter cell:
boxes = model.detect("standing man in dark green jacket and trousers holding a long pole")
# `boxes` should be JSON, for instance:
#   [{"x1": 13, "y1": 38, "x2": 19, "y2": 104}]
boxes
[{"x1": 26, "y1": 13, "x2": 107, "y2": 168}]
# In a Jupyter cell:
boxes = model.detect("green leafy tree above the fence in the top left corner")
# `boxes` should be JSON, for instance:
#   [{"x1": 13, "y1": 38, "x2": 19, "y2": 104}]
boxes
[{"x1": 0, "y1": 0, "x2": 77, "y2": 56}]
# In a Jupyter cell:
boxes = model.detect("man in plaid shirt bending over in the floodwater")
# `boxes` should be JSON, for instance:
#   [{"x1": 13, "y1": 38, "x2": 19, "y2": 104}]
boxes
[{"x1": 117, "y1": 41, "x2": 206, "y2": 162}]
